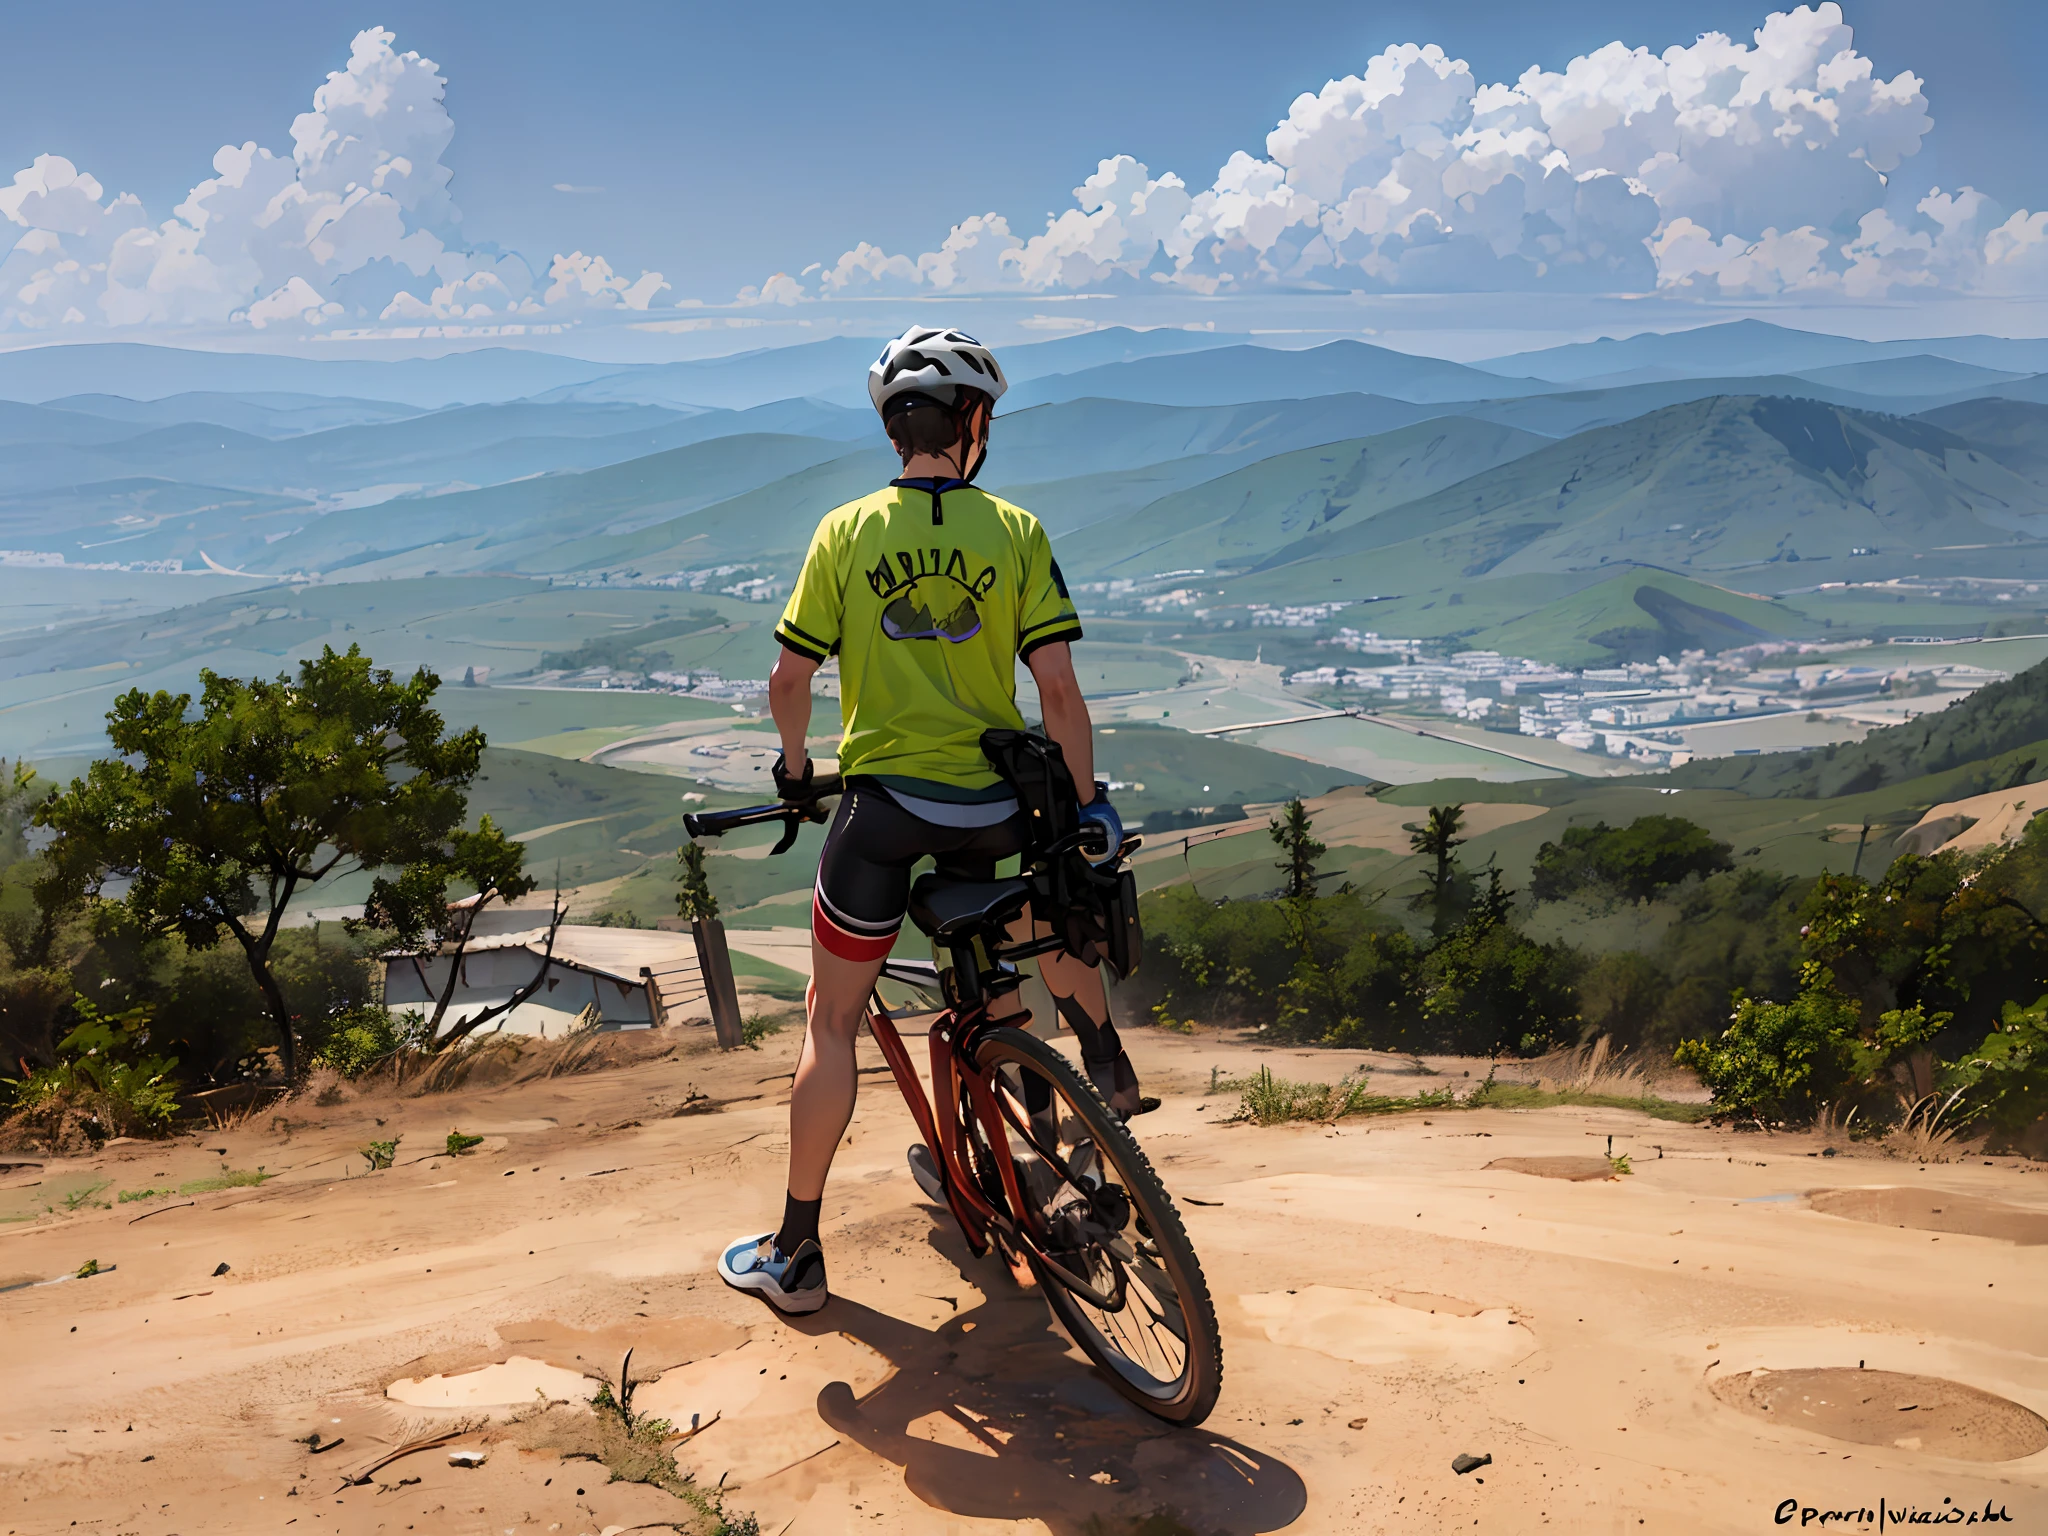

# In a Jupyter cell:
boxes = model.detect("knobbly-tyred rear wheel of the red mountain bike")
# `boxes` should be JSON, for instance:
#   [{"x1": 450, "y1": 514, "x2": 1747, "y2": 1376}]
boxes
[{"x1": 969, "y1": 1028, "x2": 1223, "y2": 1425}]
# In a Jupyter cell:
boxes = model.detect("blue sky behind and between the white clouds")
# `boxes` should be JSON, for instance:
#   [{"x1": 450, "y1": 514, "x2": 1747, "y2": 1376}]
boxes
[{"x1": 0, "y1": 0, "x2": 2048, "y2": 344}]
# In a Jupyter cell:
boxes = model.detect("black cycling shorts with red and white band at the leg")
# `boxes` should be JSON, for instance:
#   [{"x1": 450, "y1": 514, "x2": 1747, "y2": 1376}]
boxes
[{"x1": 811, "y1": 778, "x2": 1030, "y2": 961}]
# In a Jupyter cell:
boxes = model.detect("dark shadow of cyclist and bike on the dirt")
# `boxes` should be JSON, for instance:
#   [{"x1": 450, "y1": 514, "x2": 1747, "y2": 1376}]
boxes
[{"x1": 788, "y1": 1217, "x2": 1309, "y2": 1536}]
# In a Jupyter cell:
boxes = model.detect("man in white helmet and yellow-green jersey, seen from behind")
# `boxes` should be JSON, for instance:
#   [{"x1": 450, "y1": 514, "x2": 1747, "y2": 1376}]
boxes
[{"x1": 719, "y1": 326, "x2": 1139, "y2": 1313}]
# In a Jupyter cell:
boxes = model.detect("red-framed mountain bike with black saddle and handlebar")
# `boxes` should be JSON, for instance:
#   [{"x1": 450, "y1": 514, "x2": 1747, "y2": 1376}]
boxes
[{"x1": 684, "y1": 776, "x2": 1223, "y2": 1425}]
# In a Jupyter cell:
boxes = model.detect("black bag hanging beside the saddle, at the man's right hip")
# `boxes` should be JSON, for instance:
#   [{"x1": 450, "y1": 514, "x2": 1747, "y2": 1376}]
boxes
[{"x1": 981, "y1": 729, "x2": 1145, "y2": 981}]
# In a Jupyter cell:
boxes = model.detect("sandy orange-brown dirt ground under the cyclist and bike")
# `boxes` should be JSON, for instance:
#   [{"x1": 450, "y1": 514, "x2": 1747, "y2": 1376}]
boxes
[{"x1": 0, "y1": 1030, "x2": 2048, "y2": 1536}]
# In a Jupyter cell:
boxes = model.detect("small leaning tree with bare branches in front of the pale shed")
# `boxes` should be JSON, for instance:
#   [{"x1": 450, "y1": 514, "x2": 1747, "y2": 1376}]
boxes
[{"x1": 362, "y1": 817, "x2": 563, "y2": 1051}]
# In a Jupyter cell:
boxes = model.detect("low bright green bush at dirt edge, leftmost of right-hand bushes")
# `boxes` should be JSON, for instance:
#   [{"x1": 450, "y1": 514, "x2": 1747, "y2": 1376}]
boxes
[{"x1": 1675, "y1": 985, "x2": 1858, "y2": 1124}]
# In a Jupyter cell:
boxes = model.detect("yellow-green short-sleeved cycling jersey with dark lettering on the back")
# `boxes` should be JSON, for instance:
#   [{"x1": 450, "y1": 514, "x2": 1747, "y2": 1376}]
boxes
[{"x1": 774, "y1": 481, "x2": 1081, "y2": 791}]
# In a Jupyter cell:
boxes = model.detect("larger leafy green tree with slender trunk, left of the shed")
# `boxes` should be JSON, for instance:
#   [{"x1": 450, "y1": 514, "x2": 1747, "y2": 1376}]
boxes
[{"x1": 35, "y1": 645, "x2": 483, "y2": 1081}]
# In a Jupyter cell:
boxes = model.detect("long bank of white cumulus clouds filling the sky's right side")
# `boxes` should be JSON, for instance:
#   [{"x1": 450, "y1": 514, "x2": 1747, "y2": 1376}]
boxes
[{"x1": 761, "y1": 0, "x2": 2048, "y2": 303}]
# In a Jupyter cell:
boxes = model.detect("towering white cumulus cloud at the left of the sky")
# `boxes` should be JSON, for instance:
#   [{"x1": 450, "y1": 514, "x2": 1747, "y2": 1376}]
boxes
[{"x1": 0, "y1": 27, "x2": 668, "y2": 332}]
